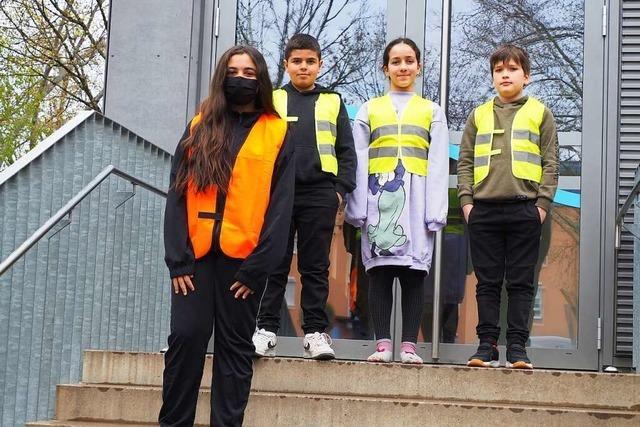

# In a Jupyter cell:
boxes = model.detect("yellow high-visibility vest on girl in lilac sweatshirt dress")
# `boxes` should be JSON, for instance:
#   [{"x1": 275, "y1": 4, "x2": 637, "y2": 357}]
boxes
[{"x1": 368, "y1": 94, "x2": 433, "y2": 176}]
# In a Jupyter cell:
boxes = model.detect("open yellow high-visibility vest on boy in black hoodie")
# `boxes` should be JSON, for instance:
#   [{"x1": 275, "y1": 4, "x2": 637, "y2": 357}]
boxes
[{"x1": 273, "y1": 89, "x2": 340, "y2": 175}]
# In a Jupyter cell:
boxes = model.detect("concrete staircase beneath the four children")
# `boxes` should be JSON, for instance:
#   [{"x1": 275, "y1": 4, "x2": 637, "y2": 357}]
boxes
[{"x1": 27, "y1": 351, "x2": 640, "y2": 427}]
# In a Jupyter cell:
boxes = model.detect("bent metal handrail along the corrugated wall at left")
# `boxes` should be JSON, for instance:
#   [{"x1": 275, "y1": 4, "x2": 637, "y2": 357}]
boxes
[{"x1": 0, "y1": 165, "x2": 167, "y2": 276}]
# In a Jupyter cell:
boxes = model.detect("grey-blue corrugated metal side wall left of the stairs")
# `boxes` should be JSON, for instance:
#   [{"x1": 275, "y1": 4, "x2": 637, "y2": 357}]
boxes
[{"x1": 0, "y1": 113, "x2": 171, "y2": 426}]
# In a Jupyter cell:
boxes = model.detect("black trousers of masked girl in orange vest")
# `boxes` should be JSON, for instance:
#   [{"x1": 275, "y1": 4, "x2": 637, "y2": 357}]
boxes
[{"x1": 158, "y1": 254, "x2": 260, "y2": 427}]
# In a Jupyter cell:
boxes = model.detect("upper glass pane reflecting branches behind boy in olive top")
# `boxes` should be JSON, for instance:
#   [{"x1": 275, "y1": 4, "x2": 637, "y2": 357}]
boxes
[{"x1": 448, "y1": 0, "x2": 584, "y2": 132}]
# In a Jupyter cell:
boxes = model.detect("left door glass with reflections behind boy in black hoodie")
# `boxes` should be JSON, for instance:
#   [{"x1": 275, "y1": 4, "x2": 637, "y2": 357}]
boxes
[{"x1": 236, "y1": 0, "x2": 387, "y2": 339}]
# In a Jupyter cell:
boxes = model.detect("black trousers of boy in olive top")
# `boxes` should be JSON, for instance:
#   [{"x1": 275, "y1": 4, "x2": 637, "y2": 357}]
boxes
[{"x1": 469, "y1": 200, "x2": 542, "y2": 346}]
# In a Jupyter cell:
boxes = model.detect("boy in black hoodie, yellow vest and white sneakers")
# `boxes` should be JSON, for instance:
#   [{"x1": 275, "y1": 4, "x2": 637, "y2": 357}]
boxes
[{"x1": 253, "y1": 34, "x2": 356, "y2": 359}]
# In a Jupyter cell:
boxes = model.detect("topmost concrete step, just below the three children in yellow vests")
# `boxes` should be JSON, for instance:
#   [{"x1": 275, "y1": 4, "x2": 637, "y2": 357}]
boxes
[{"x1": 83, "y1": 351, "x2": 640, "y2": 412}]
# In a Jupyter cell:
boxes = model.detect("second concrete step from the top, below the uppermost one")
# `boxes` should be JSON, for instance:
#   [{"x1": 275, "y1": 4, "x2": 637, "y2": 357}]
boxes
[{"x1": 52, "y1": 384, "x2": 640, "y2": 427}]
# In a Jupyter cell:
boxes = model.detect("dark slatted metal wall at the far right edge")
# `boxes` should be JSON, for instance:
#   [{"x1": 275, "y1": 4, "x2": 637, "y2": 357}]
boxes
[{"x1": 615, "y1": 0, "x2": 640, "y2": 356}]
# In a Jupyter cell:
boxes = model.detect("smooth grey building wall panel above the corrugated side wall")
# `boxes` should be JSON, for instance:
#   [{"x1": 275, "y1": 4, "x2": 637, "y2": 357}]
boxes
[{"x1": 104, "y1": 0, "x2": 206, "y2": 153}]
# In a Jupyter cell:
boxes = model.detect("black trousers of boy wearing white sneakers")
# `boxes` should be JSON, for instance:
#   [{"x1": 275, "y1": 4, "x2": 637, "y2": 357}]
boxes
[{"x1": 258, "y1": 189, "x2": 338, "y2": 334}]
